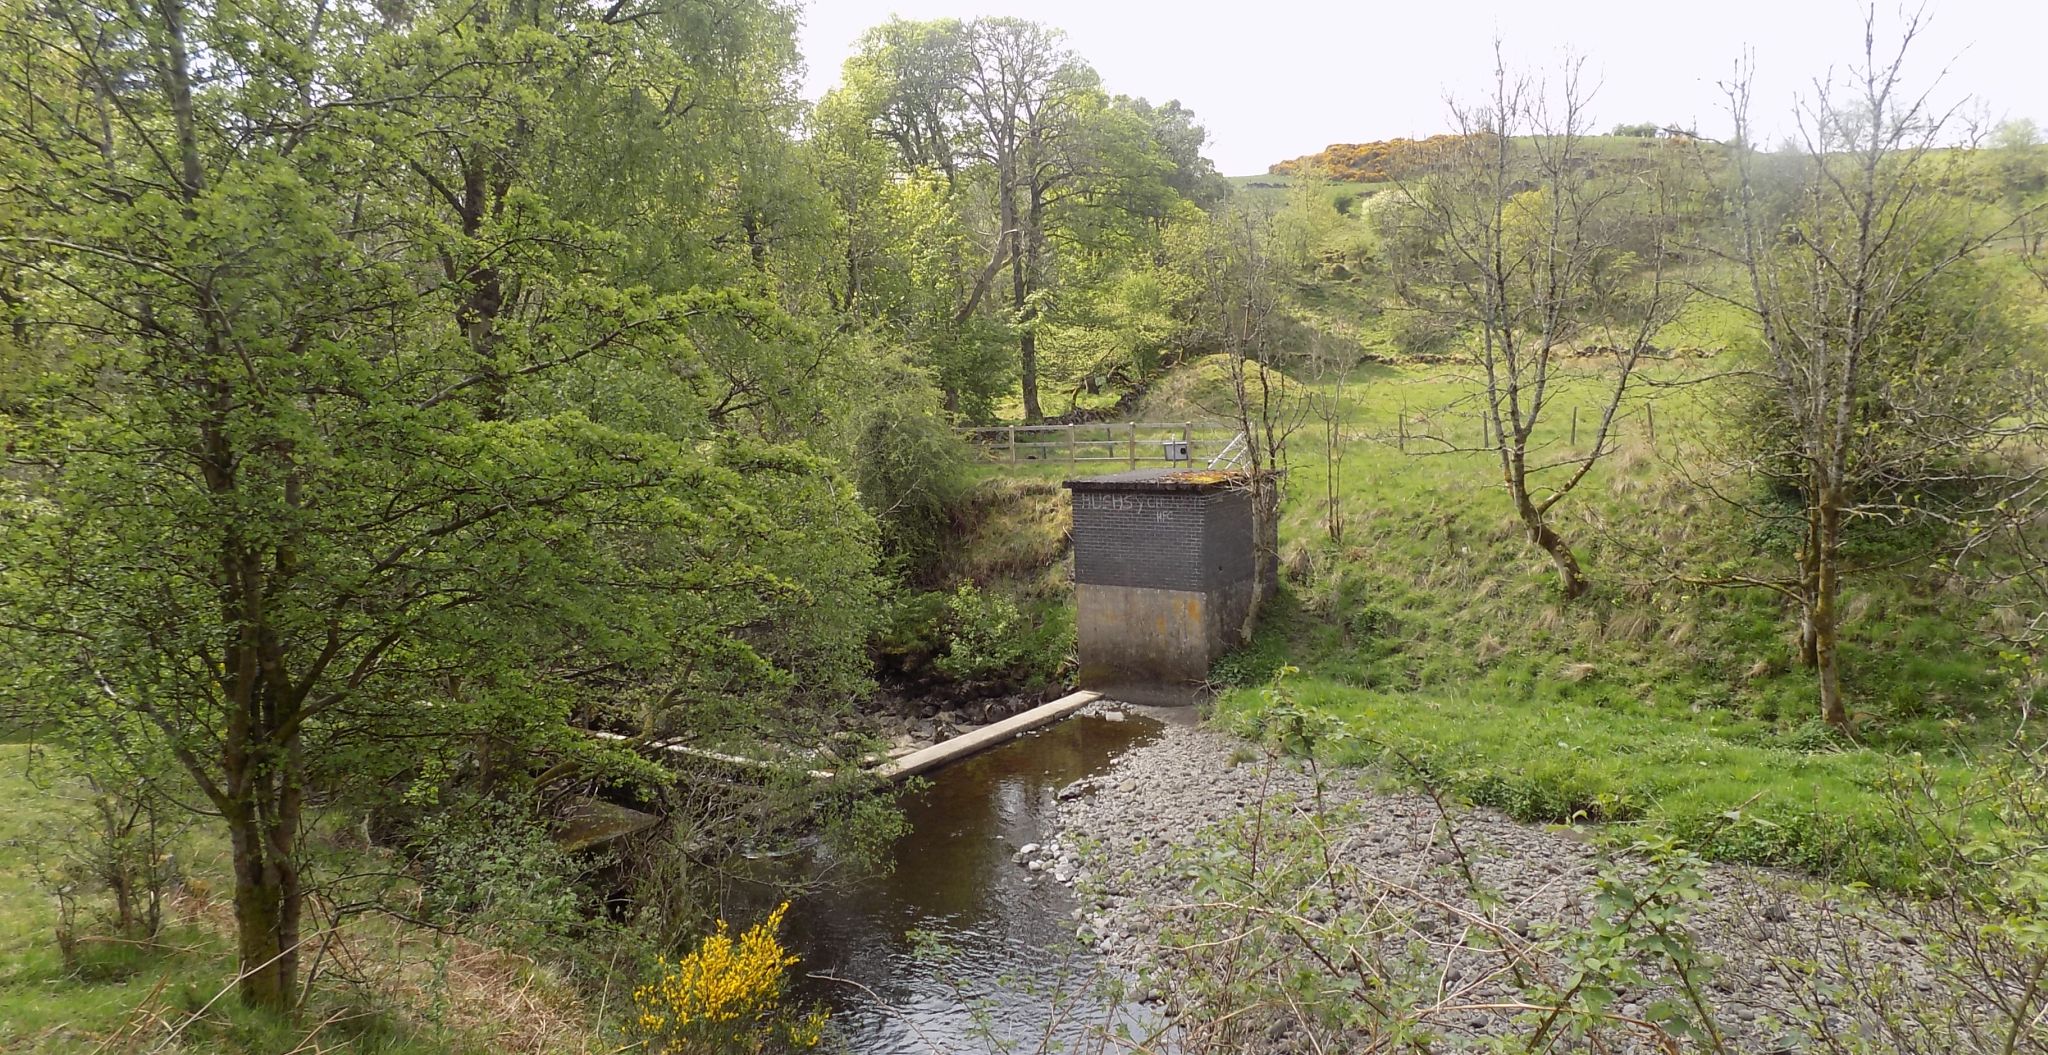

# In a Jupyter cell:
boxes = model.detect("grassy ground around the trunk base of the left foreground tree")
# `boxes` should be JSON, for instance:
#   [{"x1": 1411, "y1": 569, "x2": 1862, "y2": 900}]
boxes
[{"x1": 0, "y1": 735, "x2": 602, "y2": 1055}]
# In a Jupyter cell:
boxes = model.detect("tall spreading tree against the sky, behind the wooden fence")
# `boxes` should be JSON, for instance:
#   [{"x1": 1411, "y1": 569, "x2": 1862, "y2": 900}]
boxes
[{"x1": 817, "y1": 18, "x2": 1227, "y2": 420}]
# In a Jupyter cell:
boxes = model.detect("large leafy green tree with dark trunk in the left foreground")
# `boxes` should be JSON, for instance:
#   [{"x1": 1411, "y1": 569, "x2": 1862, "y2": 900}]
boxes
[{"x1": 0, "y1": 0, "x2": 872, "y2": 1010}]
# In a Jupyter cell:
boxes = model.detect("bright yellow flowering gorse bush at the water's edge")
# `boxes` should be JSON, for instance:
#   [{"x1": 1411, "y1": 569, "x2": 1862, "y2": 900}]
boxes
[{"x1": 633, "y1": 901, "x2": 823, "y2": 1051}]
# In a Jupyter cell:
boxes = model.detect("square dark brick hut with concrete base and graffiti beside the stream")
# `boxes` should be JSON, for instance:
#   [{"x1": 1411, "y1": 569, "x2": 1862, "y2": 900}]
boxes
[{"x1": 1067, "y1": 469, "x2": 1272, "y2": 705}]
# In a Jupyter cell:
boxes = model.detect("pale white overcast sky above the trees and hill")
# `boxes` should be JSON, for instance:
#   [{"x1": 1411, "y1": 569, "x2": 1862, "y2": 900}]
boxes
[{"x1": 803, "y1": 0, "x2": 2048, "y2": 176}]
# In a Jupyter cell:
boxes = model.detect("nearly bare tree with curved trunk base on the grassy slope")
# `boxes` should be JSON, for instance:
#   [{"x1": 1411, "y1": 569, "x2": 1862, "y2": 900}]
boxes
[{"x1": 1397, "y1": 45, "x2": 1683, "y2": 600}]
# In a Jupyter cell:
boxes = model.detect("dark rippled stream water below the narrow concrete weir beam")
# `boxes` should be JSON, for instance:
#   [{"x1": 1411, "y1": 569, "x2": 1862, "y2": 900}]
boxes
[{"x1": 729, "y1": 715, "x2": 1159, "y2": 1055}]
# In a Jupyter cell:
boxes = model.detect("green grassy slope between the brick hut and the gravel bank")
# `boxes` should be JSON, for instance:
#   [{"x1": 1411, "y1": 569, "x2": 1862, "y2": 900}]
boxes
[{"x1": 969, "y1": 350, "x2": 2015, "y2": 885}]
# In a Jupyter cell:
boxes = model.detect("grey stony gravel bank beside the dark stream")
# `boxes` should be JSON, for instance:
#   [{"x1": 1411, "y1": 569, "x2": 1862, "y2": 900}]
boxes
[{"x1": 1020, "y1": 725, "x2": 2023, "y2": 1051}]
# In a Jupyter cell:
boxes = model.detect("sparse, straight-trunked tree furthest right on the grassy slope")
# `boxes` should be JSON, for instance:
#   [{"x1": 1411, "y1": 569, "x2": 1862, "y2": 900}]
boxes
[{"x1": 1722, "y1": 12, "x2": 2025, "y2": 727}]
